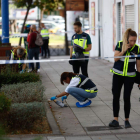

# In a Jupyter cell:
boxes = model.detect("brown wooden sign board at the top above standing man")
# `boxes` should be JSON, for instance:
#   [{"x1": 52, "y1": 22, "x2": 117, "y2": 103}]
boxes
[{"x1": 66, "y1": 0, "x2": 85, "y2": 11}]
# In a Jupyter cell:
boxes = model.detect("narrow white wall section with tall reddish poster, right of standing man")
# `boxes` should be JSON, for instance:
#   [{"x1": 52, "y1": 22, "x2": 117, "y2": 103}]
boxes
[{"x1": 89, "y1": 0, "x2": 99, "y2": 57}]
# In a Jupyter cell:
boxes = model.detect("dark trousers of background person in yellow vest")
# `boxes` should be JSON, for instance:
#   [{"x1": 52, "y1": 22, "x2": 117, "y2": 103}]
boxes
[{"x1": 41, "y1": 39, "x2": 50, "y2": 57}]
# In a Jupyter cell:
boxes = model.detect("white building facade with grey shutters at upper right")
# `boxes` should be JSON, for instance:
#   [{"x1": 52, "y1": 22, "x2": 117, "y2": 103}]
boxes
[{"x1": 89, "y1": 0, "x2": 140, "y2": 61}]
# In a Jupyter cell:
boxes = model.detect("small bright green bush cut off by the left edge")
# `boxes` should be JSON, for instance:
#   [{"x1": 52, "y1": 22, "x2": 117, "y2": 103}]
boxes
[{"x1": 0, "y1": 92, "x2": 11, "y2": 113}]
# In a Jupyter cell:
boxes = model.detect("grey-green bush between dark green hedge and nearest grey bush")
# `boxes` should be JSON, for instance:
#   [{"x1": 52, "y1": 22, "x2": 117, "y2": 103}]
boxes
[{"x1": 1, "y1": 82, "x2": 44, "y2": 103}]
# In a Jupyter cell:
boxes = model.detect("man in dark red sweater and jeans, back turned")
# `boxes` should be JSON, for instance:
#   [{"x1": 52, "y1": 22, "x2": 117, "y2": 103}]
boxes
[{"x1": 28, "y1": 25, "x2": 40, "y2": 72}]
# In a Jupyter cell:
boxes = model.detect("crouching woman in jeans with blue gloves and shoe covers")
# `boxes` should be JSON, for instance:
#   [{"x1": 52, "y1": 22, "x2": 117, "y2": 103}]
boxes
[{"x1": 51, "y1": 72, "x2": 98, "y2": 107}]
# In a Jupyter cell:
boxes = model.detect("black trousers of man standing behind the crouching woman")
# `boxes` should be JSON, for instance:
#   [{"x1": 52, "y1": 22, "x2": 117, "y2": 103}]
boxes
[{"x1": 72, "y1": 60, "x2": 88, "y2": 77}]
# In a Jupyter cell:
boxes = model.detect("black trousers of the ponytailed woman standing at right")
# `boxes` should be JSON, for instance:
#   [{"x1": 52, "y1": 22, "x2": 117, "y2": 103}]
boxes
[{"x1": 112, "y1": 74, "x2": 135, "y2": 118}]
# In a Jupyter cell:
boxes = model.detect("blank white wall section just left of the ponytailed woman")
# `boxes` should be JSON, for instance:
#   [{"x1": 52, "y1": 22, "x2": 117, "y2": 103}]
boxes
[{"x1": 102, "y1": 0, "x2": 114, "y2": 61}]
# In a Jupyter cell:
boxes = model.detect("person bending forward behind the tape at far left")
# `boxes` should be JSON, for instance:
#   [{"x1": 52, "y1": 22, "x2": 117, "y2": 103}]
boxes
[{"x1": 11, "y1": 46, "x2": 27, "y2": 73}]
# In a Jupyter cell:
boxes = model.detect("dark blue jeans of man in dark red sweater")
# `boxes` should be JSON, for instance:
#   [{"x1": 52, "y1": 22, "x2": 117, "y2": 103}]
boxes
[{"x1": 29, "y1": 47, "x2": 40, "y2": 70}]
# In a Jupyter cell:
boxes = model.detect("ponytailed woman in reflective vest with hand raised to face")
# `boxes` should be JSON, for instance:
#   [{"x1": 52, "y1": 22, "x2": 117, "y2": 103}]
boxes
[{"x1": 109, "y1": 29, "x2": 140, "y2": 128}]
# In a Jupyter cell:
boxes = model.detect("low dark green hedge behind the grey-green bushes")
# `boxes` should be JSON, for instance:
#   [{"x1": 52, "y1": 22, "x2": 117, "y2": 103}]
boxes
[{"x1": 0, "y1": 67, "x2": 40, "y2": 87}]
